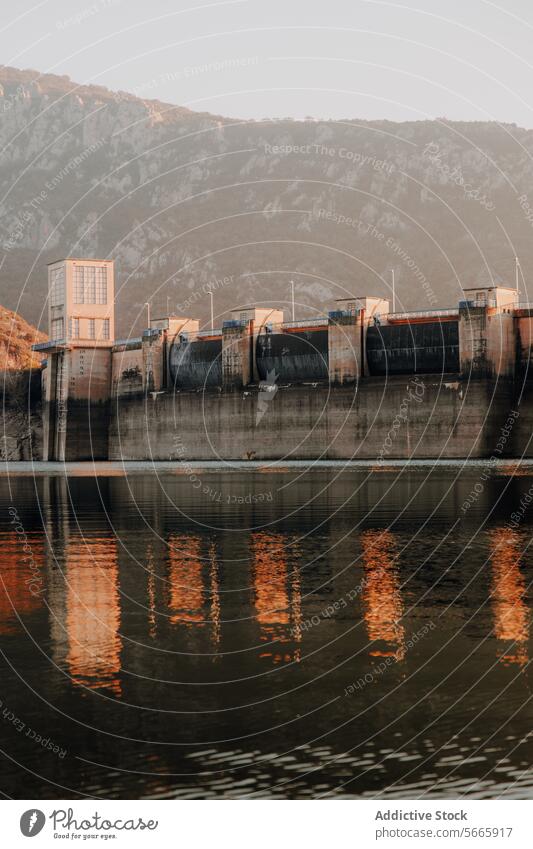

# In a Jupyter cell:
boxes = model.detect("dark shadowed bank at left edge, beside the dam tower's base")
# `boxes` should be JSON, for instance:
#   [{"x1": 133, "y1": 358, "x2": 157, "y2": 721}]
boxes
[{"x1": 0, "y1": 369, "x2": 43, "y2": 460}]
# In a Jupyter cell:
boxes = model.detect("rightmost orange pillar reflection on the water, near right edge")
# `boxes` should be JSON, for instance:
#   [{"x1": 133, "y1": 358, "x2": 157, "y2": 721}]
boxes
[{"x1": 489, "y1": 528, "x2": 529, "y2": 665}]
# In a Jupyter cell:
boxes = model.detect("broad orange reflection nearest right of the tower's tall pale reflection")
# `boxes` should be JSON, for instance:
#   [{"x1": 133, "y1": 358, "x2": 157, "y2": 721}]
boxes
[{"x1": 168, "y1": 534, "x2": 204, "y2": 625}]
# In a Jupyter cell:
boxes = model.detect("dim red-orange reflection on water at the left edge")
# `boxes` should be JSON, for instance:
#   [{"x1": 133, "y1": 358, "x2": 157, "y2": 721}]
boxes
[{"x1": 0, "y1": 526, "x2": 44, "y2": 634}]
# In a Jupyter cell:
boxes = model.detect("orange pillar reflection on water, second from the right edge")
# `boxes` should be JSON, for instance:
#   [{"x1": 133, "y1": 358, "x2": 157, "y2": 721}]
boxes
[{"x1": 361, "y1": 530, "x2": 405, "y2": 660}]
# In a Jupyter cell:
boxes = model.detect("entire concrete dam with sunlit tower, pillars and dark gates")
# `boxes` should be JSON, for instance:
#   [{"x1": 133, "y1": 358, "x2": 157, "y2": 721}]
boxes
[{"x1": 26, "y1": 258, "x2": 533, "y2": 464}]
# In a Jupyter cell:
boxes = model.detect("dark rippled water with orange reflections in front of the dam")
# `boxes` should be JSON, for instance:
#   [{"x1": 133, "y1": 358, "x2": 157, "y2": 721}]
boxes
[{"x1": 0, "y1": 464, "x2": 533, "y2": 798}]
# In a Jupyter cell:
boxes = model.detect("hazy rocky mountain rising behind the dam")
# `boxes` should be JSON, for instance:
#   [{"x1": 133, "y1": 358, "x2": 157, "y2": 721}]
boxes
[{"x1": 0, "y1": 68, "x2": 533, "y2": 336}]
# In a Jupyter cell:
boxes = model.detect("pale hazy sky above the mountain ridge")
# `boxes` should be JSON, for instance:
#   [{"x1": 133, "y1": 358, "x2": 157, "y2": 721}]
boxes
[{"x1": 0, "y1": 0, "x2": 533, "y2": 128}]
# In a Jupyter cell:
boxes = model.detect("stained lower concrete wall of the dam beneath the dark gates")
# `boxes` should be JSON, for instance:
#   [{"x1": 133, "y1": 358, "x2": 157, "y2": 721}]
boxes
[{"x1": 109, "y1": 375, "x2": 516, "y2": 462}]
